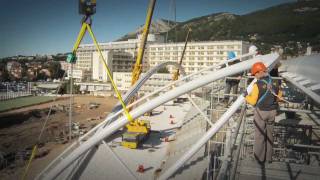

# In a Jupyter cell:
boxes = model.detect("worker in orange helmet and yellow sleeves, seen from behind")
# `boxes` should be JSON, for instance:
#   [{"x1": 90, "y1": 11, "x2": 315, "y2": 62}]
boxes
[{"x1": 244, "y1": 62, "x2": 282, "y2": 163}]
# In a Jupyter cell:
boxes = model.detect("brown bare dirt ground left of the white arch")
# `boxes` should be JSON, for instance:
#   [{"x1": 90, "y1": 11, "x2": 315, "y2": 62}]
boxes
[{"x1": 0, "y1": 96, "x2": 117, "y2": 179}]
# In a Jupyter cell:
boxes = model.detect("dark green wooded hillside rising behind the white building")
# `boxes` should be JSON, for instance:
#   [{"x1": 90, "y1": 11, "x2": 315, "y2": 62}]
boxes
[{"x1": 168, "y1": 0, "x2": 320, "y2": 53}]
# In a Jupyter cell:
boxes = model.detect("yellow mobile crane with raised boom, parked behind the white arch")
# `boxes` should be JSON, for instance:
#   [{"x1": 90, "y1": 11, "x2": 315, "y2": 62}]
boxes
[{"x1": 121, "y1": 0, "x2": 156, "y2": 149}]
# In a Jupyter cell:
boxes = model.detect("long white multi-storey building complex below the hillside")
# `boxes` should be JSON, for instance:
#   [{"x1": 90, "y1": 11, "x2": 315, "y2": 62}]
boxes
[{"x1": 71, "y1": 36, "x2": 250, "y2": 92}]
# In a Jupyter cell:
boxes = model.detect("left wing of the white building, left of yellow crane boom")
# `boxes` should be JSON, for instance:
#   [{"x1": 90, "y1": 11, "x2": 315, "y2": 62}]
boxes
[{"x1": 75, "y1": 34, "x2": 164, "y2": 81}]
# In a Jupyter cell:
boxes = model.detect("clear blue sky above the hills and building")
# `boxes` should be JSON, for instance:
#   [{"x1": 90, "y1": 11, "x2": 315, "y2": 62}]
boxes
[{"x1": 0, "y1": 0, "x2": 295, "y2": 57}]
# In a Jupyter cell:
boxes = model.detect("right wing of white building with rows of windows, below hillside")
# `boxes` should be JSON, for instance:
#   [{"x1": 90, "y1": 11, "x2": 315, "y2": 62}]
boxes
[{"x1": 147, "y1": 41, "x2": 249, "y2": 74}]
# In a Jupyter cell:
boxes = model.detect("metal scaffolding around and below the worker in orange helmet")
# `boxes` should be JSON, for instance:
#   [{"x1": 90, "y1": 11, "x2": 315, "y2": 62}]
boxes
[{"x1": 202, "y1": 76, "x2": 320, "y2": 180}]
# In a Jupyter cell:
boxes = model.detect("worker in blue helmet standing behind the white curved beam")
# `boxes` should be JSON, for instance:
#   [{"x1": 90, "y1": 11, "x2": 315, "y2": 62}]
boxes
[{"x1": 223, "y1": 51, "x2": 242, "y2": 107}]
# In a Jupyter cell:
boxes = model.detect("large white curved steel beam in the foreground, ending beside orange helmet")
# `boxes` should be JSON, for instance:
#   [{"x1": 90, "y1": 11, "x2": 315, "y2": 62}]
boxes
[{"x1": 44, "y1": 54, "x2": 279, "y2": 179}]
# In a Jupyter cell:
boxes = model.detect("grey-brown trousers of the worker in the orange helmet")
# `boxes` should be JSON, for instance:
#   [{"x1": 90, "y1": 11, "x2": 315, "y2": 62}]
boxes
[{"x1": 253, "y1": 108, "x2": 277, "y2": 162}]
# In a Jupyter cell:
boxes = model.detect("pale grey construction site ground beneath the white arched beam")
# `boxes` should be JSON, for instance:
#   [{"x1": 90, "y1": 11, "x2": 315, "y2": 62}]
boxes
[{"x1": 57, "y1": 99, "x2": 208, "y2": 180}]
